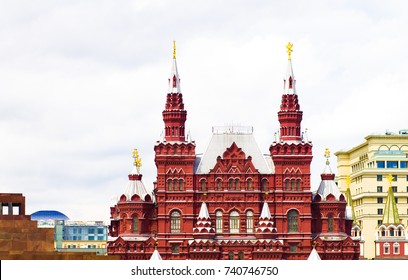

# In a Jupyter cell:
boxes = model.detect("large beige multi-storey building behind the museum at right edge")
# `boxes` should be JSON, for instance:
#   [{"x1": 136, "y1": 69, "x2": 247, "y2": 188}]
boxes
[{"x1": 335, "y1": 130, "x2": 408, "y2": 259}]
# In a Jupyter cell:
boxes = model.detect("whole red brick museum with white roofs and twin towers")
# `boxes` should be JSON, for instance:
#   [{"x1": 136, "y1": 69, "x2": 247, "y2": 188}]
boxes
[{"x1": 108, "y1": 43, "x2": 359, "y2": 260}]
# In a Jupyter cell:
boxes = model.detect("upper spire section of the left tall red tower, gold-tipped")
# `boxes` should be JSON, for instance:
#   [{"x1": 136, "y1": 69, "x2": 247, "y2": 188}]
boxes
[{"x1": 163, "y1": 41, "x2": 187, "y2": 142}]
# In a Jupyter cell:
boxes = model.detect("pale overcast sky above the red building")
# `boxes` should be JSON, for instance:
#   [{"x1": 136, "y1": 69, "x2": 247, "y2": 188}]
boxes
[{"x1": 0, "y1": 0, "x2": 408, "y2": 221}]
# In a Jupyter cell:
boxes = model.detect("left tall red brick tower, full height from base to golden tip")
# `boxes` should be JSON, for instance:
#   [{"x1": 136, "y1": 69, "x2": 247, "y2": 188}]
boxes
[{"x1": 154, "y1": 42, "x2": 199, "y2": 259}]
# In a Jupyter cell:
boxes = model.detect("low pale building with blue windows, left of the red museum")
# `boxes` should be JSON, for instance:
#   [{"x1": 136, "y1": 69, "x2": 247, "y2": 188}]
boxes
[{"x1": 55, "y1": 220, "x2": 108, "y2": 255}]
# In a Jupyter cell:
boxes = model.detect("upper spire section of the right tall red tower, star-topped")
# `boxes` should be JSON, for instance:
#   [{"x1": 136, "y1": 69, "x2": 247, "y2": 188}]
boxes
[{"x1": 278, "y1": 42, "x2": 303, "y2": 142}]
